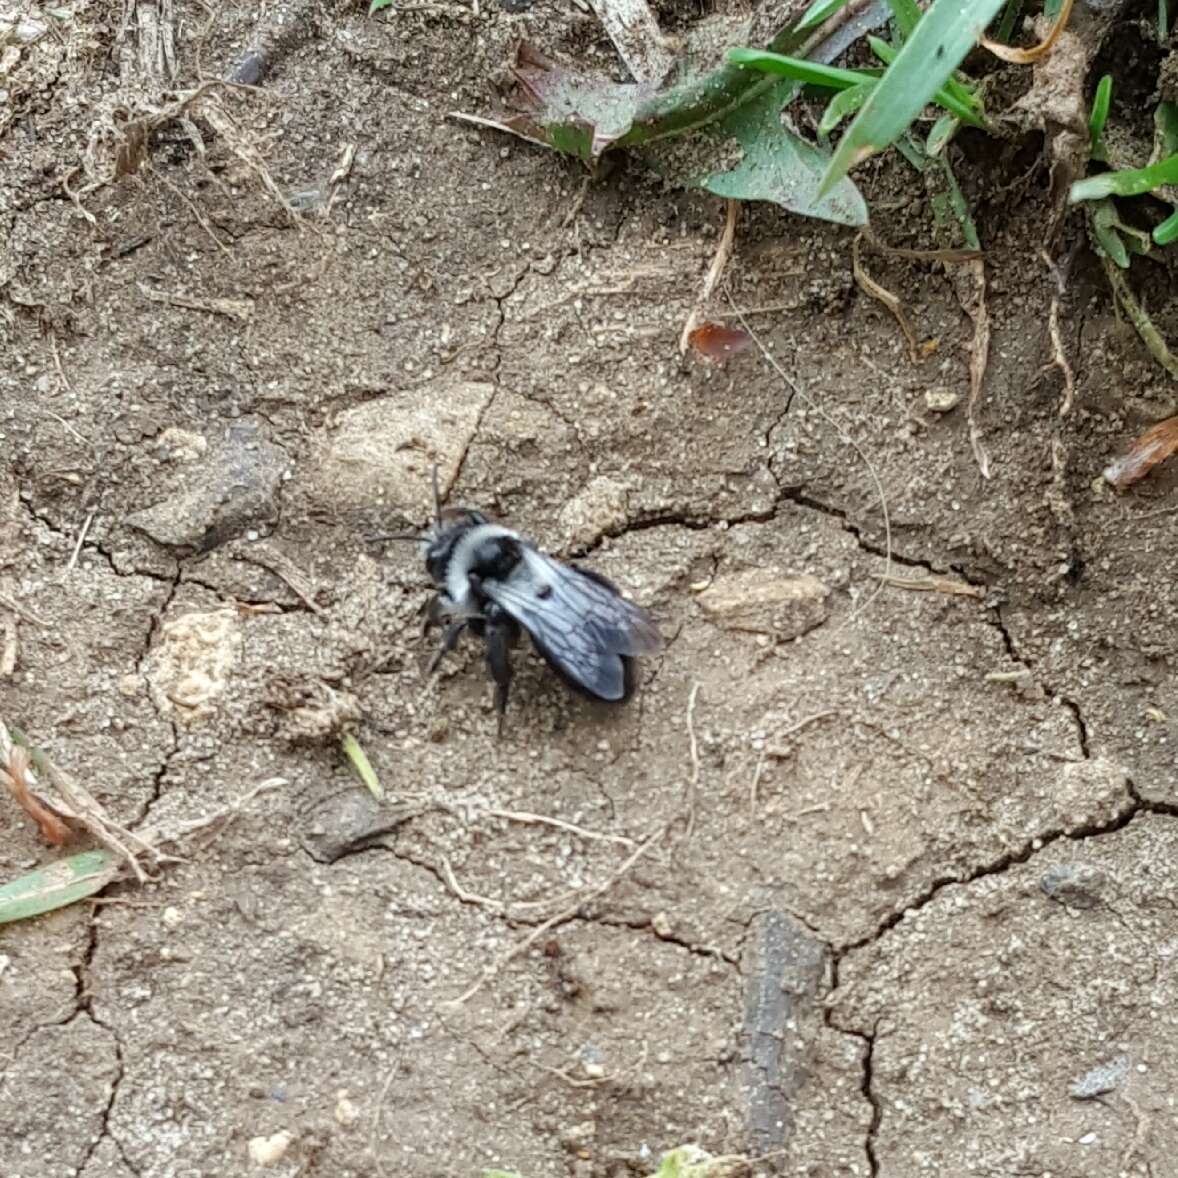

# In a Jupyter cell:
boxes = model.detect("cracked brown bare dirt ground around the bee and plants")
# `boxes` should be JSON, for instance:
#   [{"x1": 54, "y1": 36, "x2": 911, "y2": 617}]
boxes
[{"x1": 0, "y1": 0, "x2": 1178, "y2": 1178}]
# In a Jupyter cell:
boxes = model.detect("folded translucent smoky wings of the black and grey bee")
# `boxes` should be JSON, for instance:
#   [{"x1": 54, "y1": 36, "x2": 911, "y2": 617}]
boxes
[{"x1": 482, "y1": 547, "x2": 663, "y2": 700}]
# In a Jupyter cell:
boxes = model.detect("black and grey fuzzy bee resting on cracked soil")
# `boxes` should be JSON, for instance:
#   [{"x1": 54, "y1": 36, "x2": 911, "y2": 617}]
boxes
[{"x1": 372, "y1": 468, "x2": 663, "y2": 727}]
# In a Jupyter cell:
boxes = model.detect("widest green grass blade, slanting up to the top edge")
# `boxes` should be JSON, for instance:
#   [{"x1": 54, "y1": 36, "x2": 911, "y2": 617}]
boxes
[{"x1": 819, "y1": 0, "x2": 1004, "y2": 193}]
